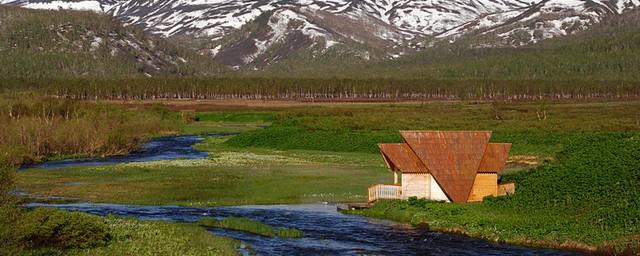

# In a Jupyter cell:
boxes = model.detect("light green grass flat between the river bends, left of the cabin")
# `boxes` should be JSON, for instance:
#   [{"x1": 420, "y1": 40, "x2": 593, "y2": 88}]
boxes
[{"x1": 17, "y1": 137, "x2": 390, "y2": 207}]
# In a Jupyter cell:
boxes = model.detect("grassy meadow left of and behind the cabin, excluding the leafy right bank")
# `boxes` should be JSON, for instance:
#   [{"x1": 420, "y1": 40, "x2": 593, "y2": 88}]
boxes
[{"x1": 17, "y1": 101, "x2": 640, "y2": 206}]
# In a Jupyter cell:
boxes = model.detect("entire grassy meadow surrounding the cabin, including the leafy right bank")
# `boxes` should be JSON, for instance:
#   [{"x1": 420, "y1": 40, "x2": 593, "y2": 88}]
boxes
[{"x1": 7, "y1": 101, "x2": 640, "y2": 251}]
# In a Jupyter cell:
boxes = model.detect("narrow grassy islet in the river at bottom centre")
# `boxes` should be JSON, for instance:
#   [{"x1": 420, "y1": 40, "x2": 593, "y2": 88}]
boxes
[{"x1": 198, "y1": 217, "x2": 304, "y2": 238}]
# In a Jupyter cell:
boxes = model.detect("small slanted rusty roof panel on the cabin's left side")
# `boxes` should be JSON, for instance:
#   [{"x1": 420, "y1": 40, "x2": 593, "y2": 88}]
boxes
[{"x1": 378, "y1": 143, "x2": 427, "y2": 173}]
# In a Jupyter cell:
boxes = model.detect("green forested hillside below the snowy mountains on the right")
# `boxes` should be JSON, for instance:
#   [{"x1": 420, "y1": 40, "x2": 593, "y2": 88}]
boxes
[{"x1": 261, "y1": 10, "x2": 640, "y2": 81}]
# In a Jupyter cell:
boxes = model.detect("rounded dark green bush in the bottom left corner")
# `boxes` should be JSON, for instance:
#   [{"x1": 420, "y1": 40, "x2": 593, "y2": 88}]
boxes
[{"x1": 17, "y1": 208, "x2": 111, "y2": 249}]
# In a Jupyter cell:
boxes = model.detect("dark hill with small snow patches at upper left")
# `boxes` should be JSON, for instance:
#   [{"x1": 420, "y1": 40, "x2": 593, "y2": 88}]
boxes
[{"x1": 0, "y1": 6, "x2": 224, "y2": 79}]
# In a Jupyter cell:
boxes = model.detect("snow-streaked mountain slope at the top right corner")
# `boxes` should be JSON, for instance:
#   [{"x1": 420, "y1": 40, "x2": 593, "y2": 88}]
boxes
[{"x1": 438, "y1": 0, "x2": 640, "y2": 47}]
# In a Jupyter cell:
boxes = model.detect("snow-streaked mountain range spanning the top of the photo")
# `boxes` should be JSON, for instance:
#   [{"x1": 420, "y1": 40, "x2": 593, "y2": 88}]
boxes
[{"x1": 0, "y1": 0, "x2": 640, "y2": 68}]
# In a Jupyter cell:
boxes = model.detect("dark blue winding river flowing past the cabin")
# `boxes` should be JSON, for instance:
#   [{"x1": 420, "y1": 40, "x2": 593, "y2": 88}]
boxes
[{"x1": 22, "y1": 134, "x2": 577, "y2": 255}]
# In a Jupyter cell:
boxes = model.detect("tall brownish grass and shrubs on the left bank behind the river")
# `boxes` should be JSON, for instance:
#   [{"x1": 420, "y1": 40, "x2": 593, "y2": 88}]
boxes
[{"x1": 0, "y1": 93, "x2": 181, "y2": 165}]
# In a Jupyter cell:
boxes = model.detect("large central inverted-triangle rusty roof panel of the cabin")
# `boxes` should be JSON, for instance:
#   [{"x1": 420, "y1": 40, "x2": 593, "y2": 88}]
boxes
[{"x1": 400, "y1": 131, "x2": 491, "y2": 202}]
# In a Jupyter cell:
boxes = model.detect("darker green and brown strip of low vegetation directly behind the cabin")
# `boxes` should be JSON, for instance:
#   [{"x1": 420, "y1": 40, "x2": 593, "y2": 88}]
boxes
[{"x1": 225, "y1": 102, "x2": 640, "y2": 157}]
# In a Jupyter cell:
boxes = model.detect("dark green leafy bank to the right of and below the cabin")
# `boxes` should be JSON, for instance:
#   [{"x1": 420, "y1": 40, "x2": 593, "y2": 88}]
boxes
[{"x1": 352, "y1": 133, "x2": 640, "y2": 253}]
